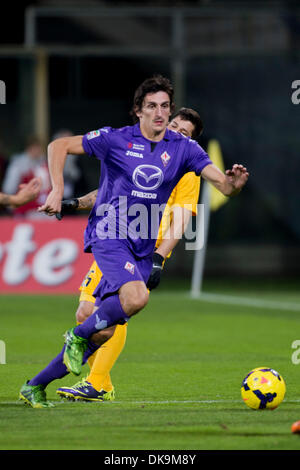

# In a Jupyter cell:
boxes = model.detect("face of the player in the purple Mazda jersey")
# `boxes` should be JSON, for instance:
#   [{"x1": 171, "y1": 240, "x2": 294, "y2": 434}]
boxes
[{"x1": 136, "y1": 91, "x2": 171, "y2": 140}]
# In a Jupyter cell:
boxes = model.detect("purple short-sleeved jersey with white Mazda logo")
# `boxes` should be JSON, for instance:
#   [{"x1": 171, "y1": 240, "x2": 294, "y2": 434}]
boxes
[{"x1": 82, "y1": 124, "x2": 212, "y2": 258}]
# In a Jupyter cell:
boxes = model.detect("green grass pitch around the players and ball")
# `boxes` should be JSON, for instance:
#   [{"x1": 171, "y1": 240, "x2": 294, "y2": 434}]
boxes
[{"x1": 0, "y1": 281, "x2": 300, "y2": 450}]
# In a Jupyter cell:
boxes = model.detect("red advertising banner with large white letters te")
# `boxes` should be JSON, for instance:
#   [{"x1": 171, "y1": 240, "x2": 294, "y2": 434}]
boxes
[{"x1": 0, "y1": 217, "x2": 93, "y2": 294}]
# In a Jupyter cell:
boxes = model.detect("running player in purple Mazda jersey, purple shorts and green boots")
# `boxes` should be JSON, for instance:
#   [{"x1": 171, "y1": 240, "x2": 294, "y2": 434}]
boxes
[{"x1": 20, "y1": 76, "x2": 249, "y2": 408}]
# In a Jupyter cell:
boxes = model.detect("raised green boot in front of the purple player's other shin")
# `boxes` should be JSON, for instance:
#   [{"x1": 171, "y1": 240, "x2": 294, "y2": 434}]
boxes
[{"x1": 63, "y1": 327, "x2": 88, "y2": 375}]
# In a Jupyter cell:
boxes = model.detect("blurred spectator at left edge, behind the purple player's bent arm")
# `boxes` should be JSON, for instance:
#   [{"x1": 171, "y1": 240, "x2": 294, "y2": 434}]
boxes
[{"x1": 2, "y1": 137, "x2": 51, "y2": 217}]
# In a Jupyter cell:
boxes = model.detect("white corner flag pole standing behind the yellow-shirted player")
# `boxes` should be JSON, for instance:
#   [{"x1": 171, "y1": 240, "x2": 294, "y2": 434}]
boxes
[{"x1": 190, "y1": 181, "x2": 210, "y2": 297}]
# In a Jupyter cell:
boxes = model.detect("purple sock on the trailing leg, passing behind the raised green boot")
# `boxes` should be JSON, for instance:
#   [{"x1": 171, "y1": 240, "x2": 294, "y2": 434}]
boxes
[{"x1": 28, "y1": 341, "x2": 99, "y2": 387}]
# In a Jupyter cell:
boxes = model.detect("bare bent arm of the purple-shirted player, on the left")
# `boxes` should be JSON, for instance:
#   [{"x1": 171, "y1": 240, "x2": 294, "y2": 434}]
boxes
[{"x1": 38, "y1": 135, "x2": 85, "y2": 215}]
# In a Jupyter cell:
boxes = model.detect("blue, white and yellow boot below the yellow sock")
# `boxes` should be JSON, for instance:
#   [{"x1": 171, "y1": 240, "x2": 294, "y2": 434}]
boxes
[{"x1": 56, "y1": 378, "x2": 115, "y2": 401}]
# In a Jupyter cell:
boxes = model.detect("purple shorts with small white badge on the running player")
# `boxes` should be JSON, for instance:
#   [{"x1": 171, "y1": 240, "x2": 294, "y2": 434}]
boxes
[{"x1": 92, "y1": 240, "x2": 152, "y2": 300}]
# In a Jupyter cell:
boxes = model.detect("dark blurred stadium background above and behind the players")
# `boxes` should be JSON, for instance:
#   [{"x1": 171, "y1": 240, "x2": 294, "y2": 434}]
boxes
[{"x1": 0, "y1": 0, "x2": 300, "y2": 289}]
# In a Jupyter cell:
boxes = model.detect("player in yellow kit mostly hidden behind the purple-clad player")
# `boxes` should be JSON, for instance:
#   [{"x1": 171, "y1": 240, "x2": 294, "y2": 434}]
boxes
[{"x1": 57, "y1": 108, "x2": 203, "y2": 401}]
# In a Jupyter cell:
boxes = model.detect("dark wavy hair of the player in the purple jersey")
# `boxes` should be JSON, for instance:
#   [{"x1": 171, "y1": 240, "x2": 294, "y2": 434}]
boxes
[{"x1": 130, "y1": 75, "x2": 174, "y2": 123}]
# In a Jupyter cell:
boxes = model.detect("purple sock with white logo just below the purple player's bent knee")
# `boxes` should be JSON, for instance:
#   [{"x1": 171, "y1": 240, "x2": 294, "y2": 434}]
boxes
[{"x1": 74, "y1": 295, "x2": 129, "y2": 338}]
